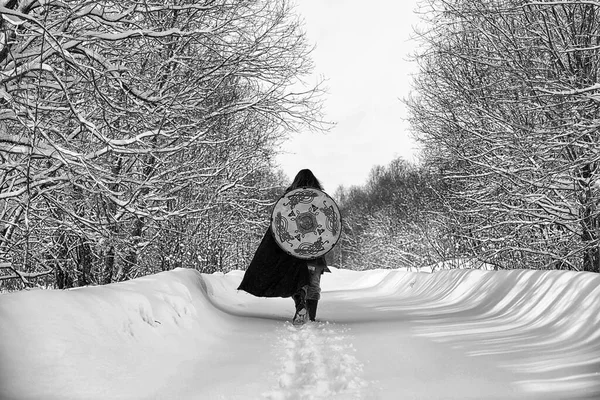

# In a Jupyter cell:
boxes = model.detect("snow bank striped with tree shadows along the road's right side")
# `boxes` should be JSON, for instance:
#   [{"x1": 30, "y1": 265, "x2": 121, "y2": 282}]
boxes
[{"x1": 322, "y1": 270, "x2": 600, "y2": 399}]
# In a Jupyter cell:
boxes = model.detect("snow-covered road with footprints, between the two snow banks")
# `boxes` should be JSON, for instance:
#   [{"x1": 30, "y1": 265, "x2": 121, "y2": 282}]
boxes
[{"x1": 207, "y1": 271, "x2": 548, "y2": 400}]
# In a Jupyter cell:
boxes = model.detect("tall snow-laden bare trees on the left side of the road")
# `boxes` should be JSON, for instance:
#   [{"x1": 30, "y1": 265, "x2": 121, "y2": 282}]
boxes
[{"x1": 0, "y1": 0, "x2": 320, "y2": 285}]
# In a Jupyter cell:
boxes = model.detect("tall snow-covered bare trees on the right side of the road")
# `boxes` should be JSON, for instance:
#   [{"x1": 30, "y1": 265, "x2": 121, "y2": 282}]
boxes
[{"x1": 409, "y1": 0, "x2": 600, "y2": 271}]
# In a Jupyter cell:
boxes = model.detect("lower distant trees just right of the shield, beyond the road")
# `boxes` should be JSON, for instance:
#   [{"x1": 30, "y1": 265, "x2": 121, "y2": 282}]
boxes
[{"x1": 328, "y1": 159, "x2": 445, "y2": 270}]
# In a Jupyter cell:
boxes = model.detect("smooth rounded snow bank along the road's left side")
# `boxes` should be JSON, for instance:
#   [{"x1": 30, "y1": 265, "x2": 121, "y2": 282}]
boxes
[{"x1": 0, "y1": 269, "x2": 238, "y2": 399}]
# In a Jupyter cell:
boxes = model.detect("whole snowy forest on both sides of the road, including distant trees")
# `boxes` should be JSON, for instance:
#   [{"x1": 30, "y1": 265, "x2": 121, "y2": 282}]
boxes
[{"x1": 0, "y1": 0, "x2": 600, "y2": 290}]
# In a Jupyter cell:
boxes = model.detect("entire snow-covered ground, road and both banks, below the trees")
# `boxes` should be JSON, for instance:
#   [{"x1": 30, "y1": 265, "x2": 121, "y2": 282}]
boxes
[{"x1": 0, "y1": 269, "x2": 600, "y2": 400}]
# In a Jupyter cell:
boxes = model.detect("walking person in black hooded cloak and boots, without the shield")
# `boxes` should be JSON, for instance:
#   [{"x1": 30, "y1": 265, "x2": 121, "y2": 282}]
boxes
[{"x1": 238, "y1": 169, "x2": 331, "y2": 324}]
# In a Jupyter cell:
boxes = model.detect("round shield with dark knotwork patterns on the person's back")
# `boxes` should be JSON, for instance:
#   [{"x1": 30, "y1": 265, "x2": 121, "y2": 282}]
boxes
[{"x1": 271, "y1": 187, "x2": 342, "y2": 259}]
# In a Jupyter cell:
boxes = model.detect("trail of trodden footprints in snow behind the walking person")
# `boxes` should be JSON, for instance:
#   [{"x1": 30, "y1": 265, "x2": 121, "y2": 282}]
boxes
[{"x1": 264, "y1": 322, "x2": 367, "y2": 400}]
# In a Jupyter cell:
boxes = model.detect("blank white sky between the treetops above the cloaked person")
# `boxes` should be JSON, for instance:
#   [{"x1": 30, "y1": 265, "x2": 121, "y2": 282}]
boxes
[{"x1": 277, "y1": 0, "x2": 418, "y2": 194}]
